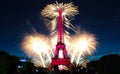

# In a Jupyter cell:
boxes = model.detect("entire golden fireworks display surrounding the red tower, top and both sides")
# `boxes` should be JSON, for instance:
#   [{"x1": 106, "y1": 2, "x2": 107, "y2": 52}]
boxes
[{"x1": 22, "y1": 2, "x2": 97, "y2": 67}]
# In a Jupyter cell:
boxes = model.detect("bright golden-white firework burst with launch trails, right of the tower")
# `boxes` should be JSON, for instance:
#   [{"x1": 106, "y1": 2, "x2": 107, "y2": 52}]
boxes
[{"x1": 69, "y1": 32, "x2": 97, "y2": 64}]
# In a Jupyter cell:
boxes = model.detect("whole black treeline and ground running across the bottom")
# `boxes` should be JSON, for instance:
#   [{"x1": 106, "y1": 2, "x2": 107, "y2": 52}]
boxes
[{"x1": 0, "y1": 51, "x2": 120, "y2": 74}]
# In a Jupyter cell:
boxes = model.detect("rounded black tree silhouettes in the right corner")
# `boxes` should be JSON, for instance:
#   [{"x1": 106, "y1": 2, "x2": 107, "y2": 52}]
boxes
[{"x1": 87, "y1": 54, "x2": 120, "y2": 74}]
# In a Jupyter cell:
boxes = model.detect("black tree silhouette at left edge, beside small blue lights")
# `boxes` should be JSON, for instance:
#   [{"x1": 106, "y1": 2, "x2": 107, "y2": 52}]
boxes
[{"x1": 0, "y1": 51, "x2": 19, "y2": 74}]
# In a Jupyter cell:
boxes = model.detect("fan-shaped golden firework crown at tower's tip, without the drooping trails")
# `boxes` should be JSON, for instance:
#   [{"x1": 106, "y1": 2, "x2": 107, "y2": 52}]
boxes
[{"x1": 41, "y1": 2, "x2": 78, "y2": 18}]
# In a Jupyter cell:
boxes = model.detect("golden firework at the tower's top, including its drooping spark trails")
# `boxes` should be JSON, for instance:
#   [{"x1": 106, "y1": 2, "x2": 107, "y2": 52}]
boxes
[{"x1": 41, "y1": 2, "x2": 78, "y2": 31}]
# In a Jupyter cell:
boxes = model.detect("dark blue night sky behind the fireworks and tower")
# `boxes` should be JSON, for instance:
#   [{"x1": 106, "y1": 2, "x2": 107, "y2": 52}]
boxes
[{"x1": 0, "y1": 0, "x2": 120, "y2": 58}]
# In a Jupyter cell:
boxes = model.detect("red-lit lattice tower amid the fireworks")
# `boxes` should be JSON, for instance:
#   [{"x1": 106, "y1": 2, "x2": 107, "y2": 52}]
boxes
[{"x1": 49, "y1": 9, "x2": 72, "y2": 69}]
